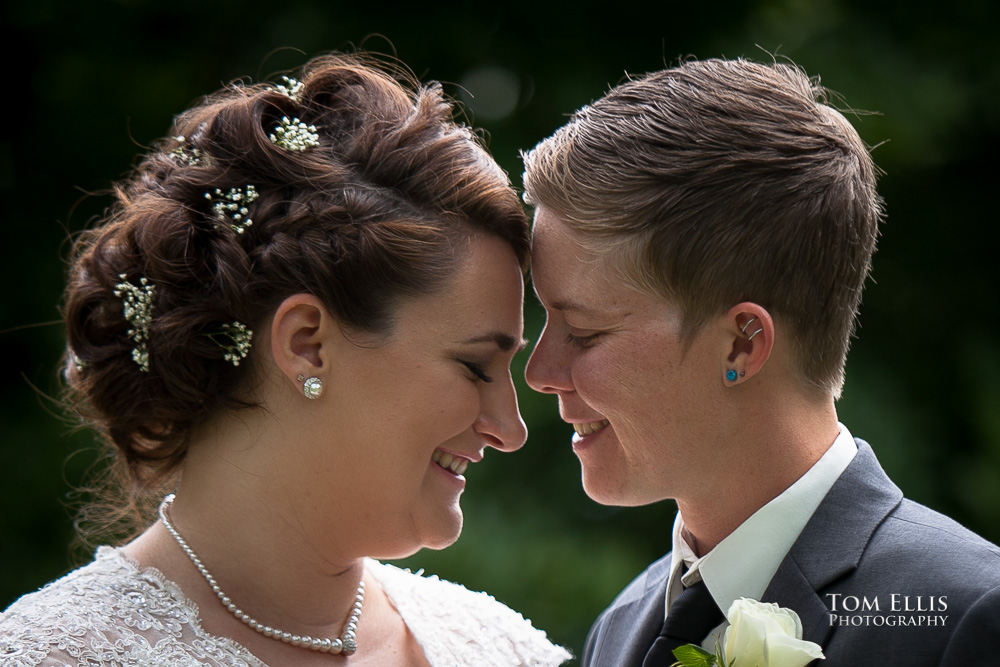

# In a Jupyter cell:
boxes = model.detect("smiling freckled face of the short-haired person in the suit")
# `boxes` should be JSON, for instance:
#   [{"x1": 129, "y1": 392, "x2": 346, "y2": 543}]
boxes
[{"x1": 525, "y1": 207, "x2": 732, "y2": 505}]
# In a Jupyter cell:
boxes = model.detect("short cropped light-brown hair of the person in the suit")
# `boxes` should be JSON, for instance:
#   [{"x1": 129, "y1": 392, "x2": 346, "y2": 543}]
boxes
[{"x1": 524, "y1": 59, "x2": 883, "y2": 397}]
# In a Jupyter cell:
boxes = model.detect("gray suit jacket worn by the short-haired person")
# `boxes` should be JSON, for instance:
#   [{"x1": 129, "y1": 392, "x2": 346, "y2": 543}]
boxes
[{"x1": 582, "y1": 440, "x2": 1000, "y2": 667}]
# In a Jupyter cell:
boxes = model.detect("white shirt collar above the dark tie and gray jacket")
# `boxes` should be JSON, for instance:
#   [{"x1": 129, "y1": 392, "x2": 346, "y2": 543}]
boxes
[{"x1": 667, "y1": 423, "x2": 858, "y2": 613}]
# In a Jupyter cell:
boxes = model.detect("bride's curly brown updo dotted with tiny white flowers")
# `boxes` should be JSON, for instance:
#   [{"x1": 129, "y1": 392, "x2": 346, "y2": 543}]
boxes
[{"x1": 64, "y1": 54, "x2": 528, "y2": 544}]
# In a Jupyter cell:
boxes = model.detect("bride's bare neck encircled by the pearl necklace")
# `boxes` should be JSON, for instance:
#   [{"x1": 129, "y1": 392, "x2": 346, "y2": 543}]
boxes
[{"x1": 126, "y1": 411, "x2": 365, "y2": 636}]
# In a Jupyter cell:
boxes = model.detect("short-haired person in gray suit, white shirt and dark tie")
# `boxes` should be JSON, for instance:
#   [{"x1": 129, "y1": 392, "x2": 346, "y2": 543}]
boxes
[{"x1": 525, "y1": 59, "x2": 1000, "y2": 667}]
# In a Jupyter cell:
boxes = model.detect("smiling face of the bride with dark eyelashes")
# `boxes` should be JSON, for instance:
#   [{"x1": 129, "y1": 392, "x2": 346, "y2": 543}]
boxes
[{"x1": 298, "y1": 237, "x2": 527, "y2": 558}]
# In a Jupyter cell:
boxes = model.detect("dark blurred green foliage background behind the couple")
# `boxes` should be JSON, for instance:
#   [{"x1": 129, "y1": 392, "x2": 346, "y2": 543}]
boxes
[{"x1": 0, "y1": 0, "x2": 1000, "y2": 651}]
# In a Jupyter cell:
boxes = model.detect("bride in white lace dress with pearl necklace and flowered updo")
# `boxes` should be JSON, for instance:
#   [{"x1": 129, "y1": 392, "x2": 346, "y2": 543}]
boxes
[{"x1": 0, "y1": 55, "x2": 570, "y2": 667}]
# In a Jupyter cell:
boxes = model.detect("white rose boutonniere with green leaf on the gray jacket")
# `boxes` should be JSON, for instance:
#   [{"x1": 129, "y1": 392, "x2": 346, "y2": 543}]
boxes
[{"x1": 674, "y1": 598, "x2": 825, "y2": 667}]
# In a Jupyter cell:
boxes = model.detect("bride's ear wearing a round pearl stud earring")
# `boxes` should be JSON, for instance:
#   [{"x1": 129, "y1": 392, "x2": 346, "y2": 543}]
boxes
[{"x1": 271, "y1": 294, "x2": 340, "y2": 390}]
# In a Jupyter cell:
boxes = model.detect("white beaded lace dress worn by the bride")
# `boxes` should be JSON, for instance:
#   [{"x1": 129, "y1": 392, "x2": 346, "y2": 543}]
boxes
[{"x1": 0, "y1": 547, "x2": 571, "y2": 667}]
